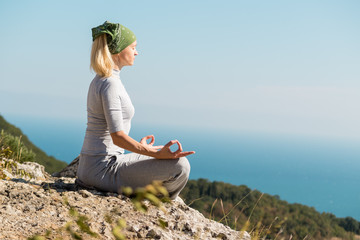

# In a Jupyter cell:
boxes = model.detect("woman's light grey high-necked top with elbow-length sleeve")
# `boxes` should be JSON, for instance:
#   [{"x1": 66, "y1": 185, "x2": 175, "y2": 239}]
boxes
[{"x1": 81, "y1": 70, "x2": 135, "y2": 155}]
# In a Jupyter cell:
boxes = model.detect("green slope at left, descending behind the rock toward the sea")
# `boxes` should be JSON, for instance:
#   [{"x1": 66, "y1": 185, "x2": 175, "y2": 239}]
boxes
[{"x1": 0, "y1": 115, "x2": 67, "y2": 173}]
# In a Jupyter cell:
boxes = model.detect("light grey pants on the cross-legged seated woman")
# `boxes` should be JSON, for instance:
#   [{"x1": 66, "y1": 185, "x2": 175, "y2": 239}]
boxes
[{"x1": 77, "y1": 153, "x2": 190, "y2": 199}]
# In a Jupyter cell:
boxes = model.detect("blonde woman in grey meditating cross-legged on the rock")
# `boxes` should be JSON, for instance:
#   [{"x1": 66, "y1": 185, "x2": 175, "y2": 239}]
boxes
[{"x1": 77, "y1": 22, "x2": 195, "y2": 199}]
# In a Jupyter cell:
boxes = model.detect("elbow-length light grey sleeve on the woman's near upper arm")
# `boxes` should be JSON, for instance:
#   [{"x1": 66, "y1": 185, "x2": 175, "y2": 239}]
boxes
[{"x1": 101, "y1": 79, "x2": 125, "y2": 133}]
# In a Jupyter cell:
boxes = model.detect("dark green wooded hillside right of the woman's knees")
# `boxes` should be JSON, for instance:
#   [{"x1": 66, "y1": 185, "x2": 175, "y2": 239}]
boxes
[{"x1": 180, "y1": 179, "x2": 360, "y2": 240}]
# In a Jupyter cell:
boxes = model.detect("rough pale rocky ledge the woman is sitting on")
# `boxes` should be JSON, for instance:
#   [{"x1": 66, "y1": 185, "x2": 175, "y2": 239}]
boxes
[{"x1": 0, "y1": 158, "x2": 250, "y2": 240}]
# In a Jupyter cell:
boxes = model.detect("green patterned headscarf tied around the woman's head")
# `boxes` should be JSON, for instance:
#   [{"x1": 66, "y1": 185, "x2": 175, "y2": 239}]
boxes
[{"x1": 91, "y1": 21, "x2": 136, "y2": 54}]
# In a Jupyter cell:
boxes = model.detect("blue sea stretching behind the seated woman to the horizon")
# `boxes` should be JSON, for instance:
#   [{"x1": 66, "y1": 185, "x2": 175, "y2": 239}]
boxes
[{"x1": 6, "y1": 116, "x2": 360, "y2": 221}]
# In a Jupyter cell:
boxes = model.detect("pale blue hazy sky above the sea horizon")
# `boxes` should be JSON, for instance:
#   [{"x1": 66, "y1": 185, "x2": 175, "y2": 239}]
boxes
[{"x1": 0, "y1": 0, "x2": 360, "y2": 140}]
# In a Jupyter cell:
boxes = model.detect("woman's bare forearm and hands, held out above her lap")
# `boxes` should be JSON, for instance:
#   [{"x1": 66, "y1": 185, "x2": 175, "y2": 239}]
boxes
[{"x1": 111, "y1": 131, "x2": 195, "y2": 159}]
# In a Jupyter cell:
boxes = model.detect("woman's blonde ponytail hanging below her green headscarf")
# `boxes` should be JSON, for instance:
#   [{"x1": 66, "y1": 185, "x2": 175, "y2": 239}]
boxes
[{"x1": 90, "y1": 34, "x2": 114, "y2": 77}]
